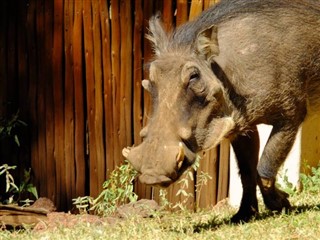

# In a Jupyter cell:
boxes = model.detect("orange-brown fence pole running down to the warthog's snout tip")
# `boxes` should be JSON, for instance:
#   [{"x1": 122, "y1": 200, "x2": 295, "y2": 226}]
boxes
[{"x1": 116, "y1": 1, "x2": 133, "y2": 158}]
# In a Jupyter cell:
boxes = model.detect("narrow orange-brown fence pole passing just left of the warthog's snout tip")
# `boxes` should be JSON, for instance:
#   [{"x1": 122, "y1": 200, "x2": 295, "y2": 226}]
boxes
[{"x1": 111, "y1": 0, "x2": 121, "y2": 167}]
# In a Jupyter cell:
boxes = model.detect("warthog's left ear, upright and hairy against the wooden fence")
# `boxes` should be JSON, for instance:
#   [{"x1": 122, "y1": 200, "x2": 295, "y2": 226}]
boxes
[{"x1": 146, "y1": 14, "x2": 169, "y2": 56}]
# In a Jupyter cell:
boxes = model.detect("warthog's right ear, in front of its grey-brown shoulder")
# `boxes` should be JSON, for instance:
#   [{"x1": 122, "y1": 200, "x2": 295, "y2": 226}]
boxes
[{"x1": 196, "y1": 25, "x2": 219, "y2": 61}]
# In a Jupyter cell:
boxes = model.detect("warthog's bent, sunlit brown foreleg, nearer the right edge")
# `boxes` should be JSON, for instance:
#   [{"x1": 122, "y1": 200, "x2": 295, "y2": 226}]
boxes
[{"x1": 258, "y1": 125, "x2": 299, "y2": 211}]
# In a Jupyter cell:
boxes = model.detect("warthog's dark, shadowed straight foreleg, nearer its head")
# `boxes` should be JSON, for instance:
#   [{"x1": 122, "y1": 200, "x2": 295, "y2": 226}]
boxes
[{"x1": 231, "y1": 128, "x2": 259, "y2": 223}]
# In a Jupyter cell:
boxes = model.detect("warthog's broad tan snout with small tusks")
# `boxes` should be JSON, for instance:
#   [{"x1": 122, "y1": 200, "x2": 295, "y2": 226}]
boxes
[{"x1": 122, "y1": 142, "x2": 195, "y2": 187}]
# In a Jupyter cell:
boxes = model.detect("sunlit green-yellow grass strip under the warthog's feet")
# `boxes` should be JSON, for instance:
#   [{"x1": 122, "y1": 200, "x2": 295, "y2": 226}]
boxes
[{"x1": 0, "y1": 191, "x2": 320, "y2": 240}]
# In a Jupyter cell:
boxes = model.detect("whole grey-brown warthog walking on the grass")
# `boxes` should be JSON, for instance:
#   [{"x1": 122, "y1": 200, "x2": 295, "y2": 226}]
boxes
[{"x1": 123, "y1": 0, "x2": 320, "y2": 222}]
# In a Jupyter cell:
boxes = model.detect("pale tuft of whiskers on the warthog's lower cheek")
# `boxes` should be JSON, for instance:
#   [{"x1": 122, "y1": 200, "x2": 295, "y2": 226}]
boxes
[{"x1": 202, "y1": 117, "x2": 235, "y2": 150}]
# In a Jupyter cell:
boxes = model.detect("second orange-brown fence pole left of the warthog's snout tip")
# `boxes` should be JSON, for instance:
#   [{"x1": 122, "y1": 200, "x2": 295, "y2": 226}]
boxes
[{"x1": 99, "y1": 0, "x2": 114, "y2": 178}]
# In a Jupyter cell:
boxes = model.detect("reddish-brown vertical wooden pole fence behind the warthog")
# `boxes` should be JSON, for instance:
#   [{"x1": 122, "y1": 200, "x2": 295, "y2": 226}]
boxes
[{"x1": 0, "y1": 0, "x2": 229, "y2": 210}]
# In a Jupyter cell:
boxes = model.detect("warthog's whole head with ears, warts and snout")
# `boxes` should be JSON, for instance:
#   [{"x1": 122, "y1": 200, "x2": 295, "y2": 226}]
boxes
[{"x1": 123, "y1": 18, "x2": 234, "y2": 186}]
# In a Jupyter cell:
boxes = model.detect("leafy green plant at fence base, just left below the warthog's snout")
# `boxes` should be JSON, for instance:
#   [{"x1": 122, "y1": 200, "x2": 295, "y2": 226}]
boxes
[{"x1": 73, "y1": 162, "x2": 138, "y2": 216}]
